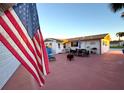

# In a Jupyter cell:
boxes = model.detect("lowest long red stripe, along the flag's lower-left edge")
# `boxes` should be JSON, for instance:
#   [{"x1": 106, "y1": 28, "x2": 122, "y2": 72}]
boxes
[{"x1": 0, "y1": 34, "x2": 41, "y2": 86}]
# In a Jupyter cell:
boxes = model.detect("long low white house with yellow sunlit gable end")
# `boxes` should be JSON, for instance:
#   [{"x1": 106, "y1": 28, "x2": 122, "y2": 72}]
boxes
[{"x1": 65, "y1": 34, "x2": 110, "y2": 54}]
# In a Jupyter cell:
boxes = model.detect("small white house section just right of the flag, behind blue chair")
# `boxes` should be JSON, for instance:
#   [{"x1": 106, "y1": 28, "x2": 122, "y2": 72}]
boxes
[{"x1": 44, "y1": 38, "x2": 64, "y2": 54}]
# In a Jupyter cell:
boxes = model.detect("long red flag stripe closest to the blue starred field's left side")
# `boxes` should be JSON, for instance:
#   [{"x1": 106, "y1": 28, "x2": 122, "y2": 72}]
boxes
[{"x1": 5, "y1": 11, "x2": 43, "y2": 72}]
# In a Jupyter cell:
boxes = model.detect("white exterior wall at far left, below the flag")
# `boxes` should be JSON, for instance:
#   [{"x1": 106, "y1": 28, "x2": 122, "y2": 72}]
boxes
[{"x1": 0, "y1": 42, "x2": 20, "y2": 89}]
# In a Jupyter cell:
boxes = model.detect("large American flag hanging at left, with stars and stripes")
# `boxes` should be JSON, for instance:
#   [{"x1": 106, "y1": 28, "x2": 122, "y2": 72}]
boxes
[{"x1": 0, "y1": 3, "x2": 49, "y2": 86}]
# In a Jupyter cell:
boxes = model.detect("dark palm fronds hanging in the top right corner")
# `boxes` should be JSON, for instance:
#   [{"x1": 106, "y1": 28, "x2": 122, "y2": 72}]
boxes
[{"x1": 110, "y1": 3, "x2": 124, "y2": 17}]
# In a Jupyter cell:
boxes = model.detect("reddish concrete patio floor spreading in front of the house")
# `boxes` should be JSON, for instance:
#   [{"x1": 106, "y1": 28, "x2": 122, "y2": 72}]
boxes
[{"x1": 3, "y1": 51, "x2": 124, "y2": 90}]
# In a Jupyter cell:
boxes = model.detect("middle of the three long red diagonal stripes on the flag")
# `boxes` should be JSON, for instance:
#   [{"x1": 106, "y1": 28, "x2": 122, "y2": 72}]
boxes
[{"x1": 0, "y1": 17, "x2": 44, "y2": 82}]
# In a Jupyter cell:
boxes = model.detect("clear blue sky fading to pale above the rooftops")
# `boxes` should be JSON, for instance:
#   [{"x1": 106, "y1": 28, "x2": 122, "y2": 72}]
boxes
[{"x1": 37, "y1": 3, "x2": 124, "y2": 40}]
